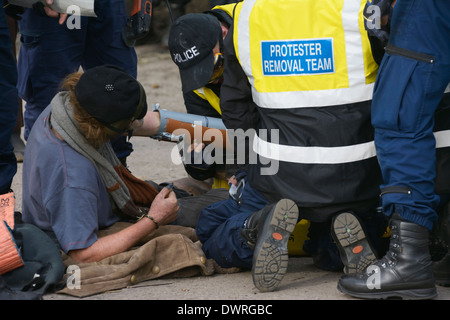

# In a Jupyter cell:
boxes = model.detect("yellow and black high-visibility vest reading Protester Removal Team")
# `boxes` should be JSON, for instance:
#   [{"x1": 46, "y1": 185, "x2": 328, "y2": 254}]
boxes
[{"x1": 229, "y1": 0, "x2": 381, "y2": 216}]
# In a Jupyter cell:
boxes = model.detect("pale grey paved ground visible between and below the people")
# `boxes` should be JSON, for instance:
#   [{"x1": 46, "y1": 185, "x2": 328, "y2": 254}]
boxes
[{"x1": 8, "y1": 22, "x2": 450, "y2": 303}]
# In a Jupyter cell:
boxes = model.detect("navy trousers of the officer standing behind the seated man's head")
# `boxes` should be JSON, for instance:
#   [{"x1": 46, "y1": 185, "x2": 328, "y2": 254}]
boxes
[{"x1": 18, "y1": 0, "x2": 137, "y2": 158}]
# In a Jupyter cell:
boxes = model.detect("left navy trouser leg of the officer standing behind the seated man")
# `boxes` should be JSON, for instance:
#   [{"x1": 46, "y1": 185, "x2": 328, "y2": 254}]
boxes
[{"x1": 17, "y1": 9, "x2": 87, "y2": 139}]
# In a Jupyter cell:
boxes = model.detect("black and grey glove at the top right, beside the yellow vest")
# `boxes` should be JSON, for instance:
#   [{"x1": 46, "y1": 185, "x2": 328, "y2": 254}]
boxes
[{"x1": 363, "y1": 0, "x2": 393, "y2": 46}]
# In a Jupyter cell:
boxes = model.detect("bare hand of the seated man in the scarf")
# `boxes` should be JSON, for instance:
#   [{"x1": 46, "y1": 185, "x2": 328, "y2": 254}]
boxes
[{"x1": 148, "y1": 184, "x2": 178, "y2": 225}]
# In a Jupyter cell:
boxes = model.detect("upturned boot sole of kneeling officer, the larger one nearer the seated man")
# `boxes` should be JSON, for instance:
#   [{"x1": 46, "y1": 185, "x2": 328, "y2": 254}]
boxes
[{"x1": 252, "y1": 199, "x2": 298, "y2": 292}]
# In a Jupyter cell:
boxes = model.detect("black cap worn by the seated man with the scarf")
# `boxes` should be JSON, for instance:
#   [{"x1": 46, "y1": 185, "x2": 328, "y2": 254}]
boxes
[{"x1": 75, "y1": 65, "x2": 147, "y2": 131}]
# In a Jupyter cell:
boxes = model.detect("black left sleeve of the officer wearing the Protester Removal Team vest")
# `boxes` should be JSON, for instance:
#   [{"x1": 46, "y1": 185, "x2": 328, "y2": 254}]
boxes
[{"x1": 220, "y1": 22, "x2": 259, "y2": 131}]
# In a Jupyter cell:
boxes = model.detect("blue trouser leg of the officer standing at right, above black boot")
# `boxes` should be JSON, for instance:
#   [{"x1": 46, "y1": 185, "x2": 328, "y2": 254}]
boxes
[{"x1": 372, "y1": 0, "x2": 450, "y2": 230}]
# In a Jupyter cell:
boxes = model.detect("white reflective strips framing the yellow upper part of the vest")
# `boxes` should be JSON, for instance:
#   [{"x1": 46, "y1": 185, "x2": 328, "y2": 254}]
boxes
[{"x1": 237, "y1": 0, "x2": 374, "y2": 109}]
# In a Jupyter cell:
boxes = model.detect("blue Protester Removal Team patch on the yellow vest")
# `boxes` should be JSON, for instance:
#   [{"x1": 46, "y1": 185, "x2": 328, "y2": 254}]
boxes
[{"x1": 261, "y1": 38, "x2": 334, "y2": 76}]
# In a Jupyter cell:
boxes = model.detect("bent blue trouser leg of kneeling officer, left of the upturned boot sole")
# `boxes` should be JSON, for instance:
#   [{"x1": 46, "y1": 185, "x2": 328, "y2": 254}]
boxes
[{"x1": 196, "y1": 183, "x2": 267, "y2": 269}]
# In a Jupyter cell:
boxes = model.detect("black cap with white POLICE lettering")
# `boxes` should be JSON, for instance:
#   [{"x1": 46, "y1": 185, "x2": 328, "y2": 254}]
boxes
[{"x1": 169, "y1": 13, "x2": 222, "y2": 92}]
